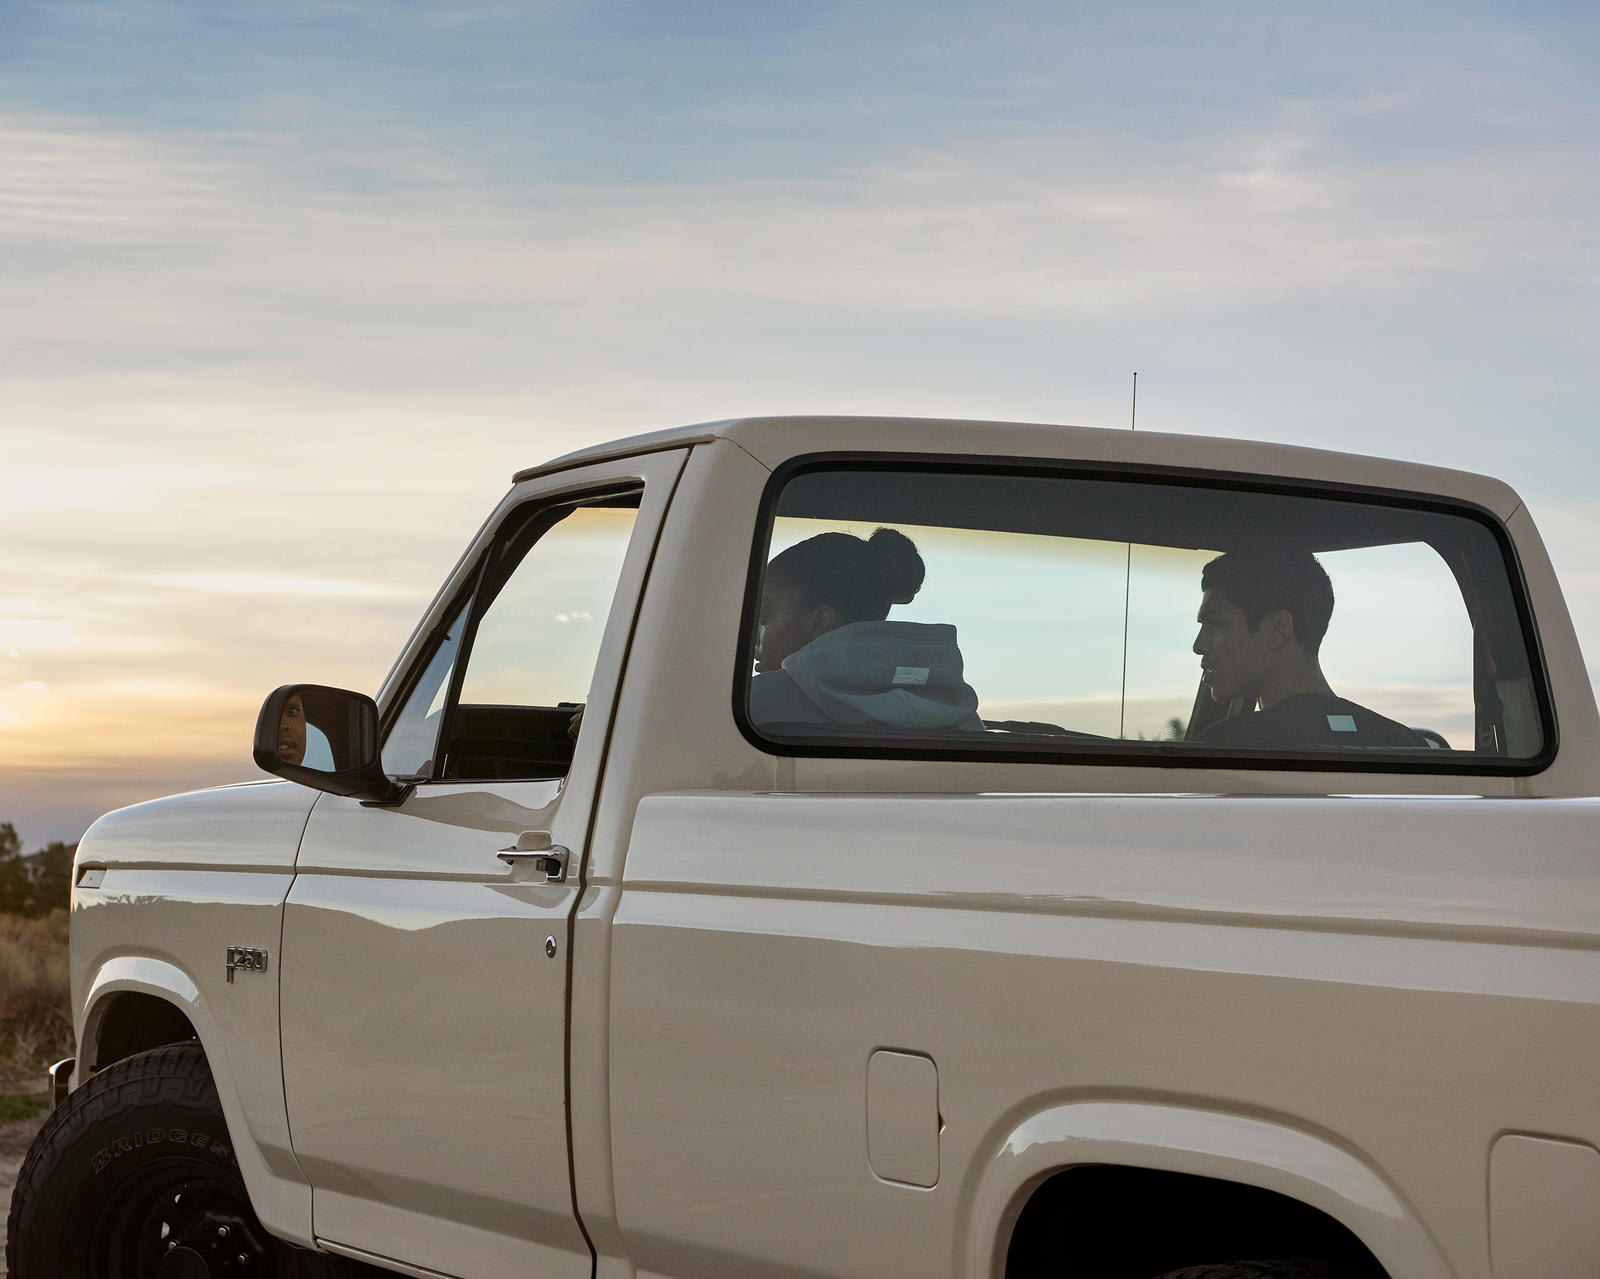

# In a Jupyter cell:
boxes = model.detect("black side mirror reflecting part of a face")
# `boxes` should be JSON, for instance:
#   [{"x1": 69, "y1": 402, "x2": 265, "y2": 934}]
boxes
[{"x1": 254, "y1": 684, "x2": 413, "y2": 804}]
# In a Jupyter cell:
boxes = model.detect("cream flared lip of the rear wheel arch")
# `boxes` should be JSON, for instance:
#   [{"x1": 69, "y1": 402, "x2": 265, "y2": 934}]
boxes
[{"x1": 965, "y1": 1100, "x2": 1453, "y2": 1279}]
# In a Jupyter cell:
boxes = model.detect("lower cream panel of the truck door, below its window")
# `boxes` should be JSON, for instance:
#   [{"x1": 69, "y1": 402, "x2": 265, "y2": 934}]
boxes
[{"x1": 282, "y1": 783, "x2": 589, "y2": 1279}]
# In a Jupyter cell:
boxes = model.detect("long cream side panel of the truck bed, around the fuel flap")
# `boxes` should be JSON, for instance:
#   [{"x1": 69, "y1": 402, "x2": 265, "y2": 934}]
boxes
[{"x1": 611, "y1": 794, "x2": 1600, "y2": 1276}]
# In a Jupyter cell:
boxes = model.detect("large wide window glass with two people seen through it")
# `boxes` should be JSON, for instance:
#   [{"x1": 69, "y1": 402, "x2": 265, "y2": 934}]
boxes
[{"x1": 739, "y1": 464, "x2": 1550, "y2": 772}]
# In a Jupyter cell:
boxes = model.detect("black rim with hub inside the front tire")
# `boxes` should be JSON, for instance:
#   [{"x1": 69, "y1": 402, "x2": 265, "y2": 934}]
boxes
[{"x1": 88, "y1": 1159, "x2": 278, "y2": 1279}]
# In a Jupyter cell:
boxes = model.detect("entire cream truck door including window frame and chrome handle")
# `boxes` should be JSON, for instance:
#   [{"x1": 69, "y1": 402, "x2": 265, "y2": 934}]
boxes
[{"x1": 280, "y1": 450, "x2": 686, "y2": 1279}]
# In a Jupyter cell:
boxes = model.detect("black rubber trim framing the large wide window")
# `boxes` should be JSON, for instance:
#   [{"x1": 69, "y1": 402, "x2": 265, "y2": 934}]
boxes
[{"x1": 733, "y1": 450, "x2": 1560, "y2": 776}]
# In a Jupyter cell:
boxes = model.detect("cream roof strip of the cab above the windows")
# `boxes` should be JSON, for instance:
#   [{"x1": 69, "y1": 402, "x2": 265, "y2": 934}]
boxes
[{"x1": 515, "y1": 415, "x2": 1520, "y2": 520}]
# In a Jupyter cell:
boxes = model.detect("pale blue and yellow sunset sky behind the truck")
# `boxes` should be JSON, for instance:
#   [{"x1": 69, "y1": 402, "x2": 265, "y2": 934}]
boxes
[{"x1": 0, "y1": 0, "x2": 1600, "y2": 848}]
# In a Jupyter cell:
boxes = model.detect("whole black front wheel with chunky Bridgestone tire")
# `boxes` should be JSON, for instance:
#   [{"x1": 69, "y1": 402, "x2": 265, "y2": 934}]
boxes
[{"x1": 5, "y1": 1040, "x2": 350, "y2": 1279}]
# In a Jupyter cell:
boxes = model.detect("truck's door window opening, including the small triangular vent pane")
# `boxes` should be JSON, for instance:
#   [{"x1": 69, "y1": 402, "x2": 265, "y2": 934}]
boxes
[{"x1": 384, "y1": 490, "x2": 640, "y2": 780}]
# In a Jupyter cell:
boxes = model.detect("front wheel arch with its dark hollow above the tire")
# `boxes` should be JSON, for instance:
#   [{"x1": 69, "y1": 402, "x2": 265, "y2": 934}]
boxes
[{"x1": 74, "y1": 954, "x2": 314, "y2": 1247}]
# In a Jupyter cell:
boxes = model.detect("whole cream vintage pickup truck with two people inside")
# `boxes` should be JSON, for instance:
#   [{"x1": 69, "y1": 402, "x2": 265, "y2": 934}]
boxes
[{"x1": 6, "y1": 418, "x2": 1600, "y2": 1279}]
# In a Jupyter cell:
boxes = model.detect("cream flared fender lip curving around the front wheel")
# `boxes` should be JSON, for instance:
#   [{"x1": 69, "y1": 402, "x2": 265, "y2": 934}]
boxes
[{"x1": 75, "y1": 954, "x2": 314, "y2": 1247}]
